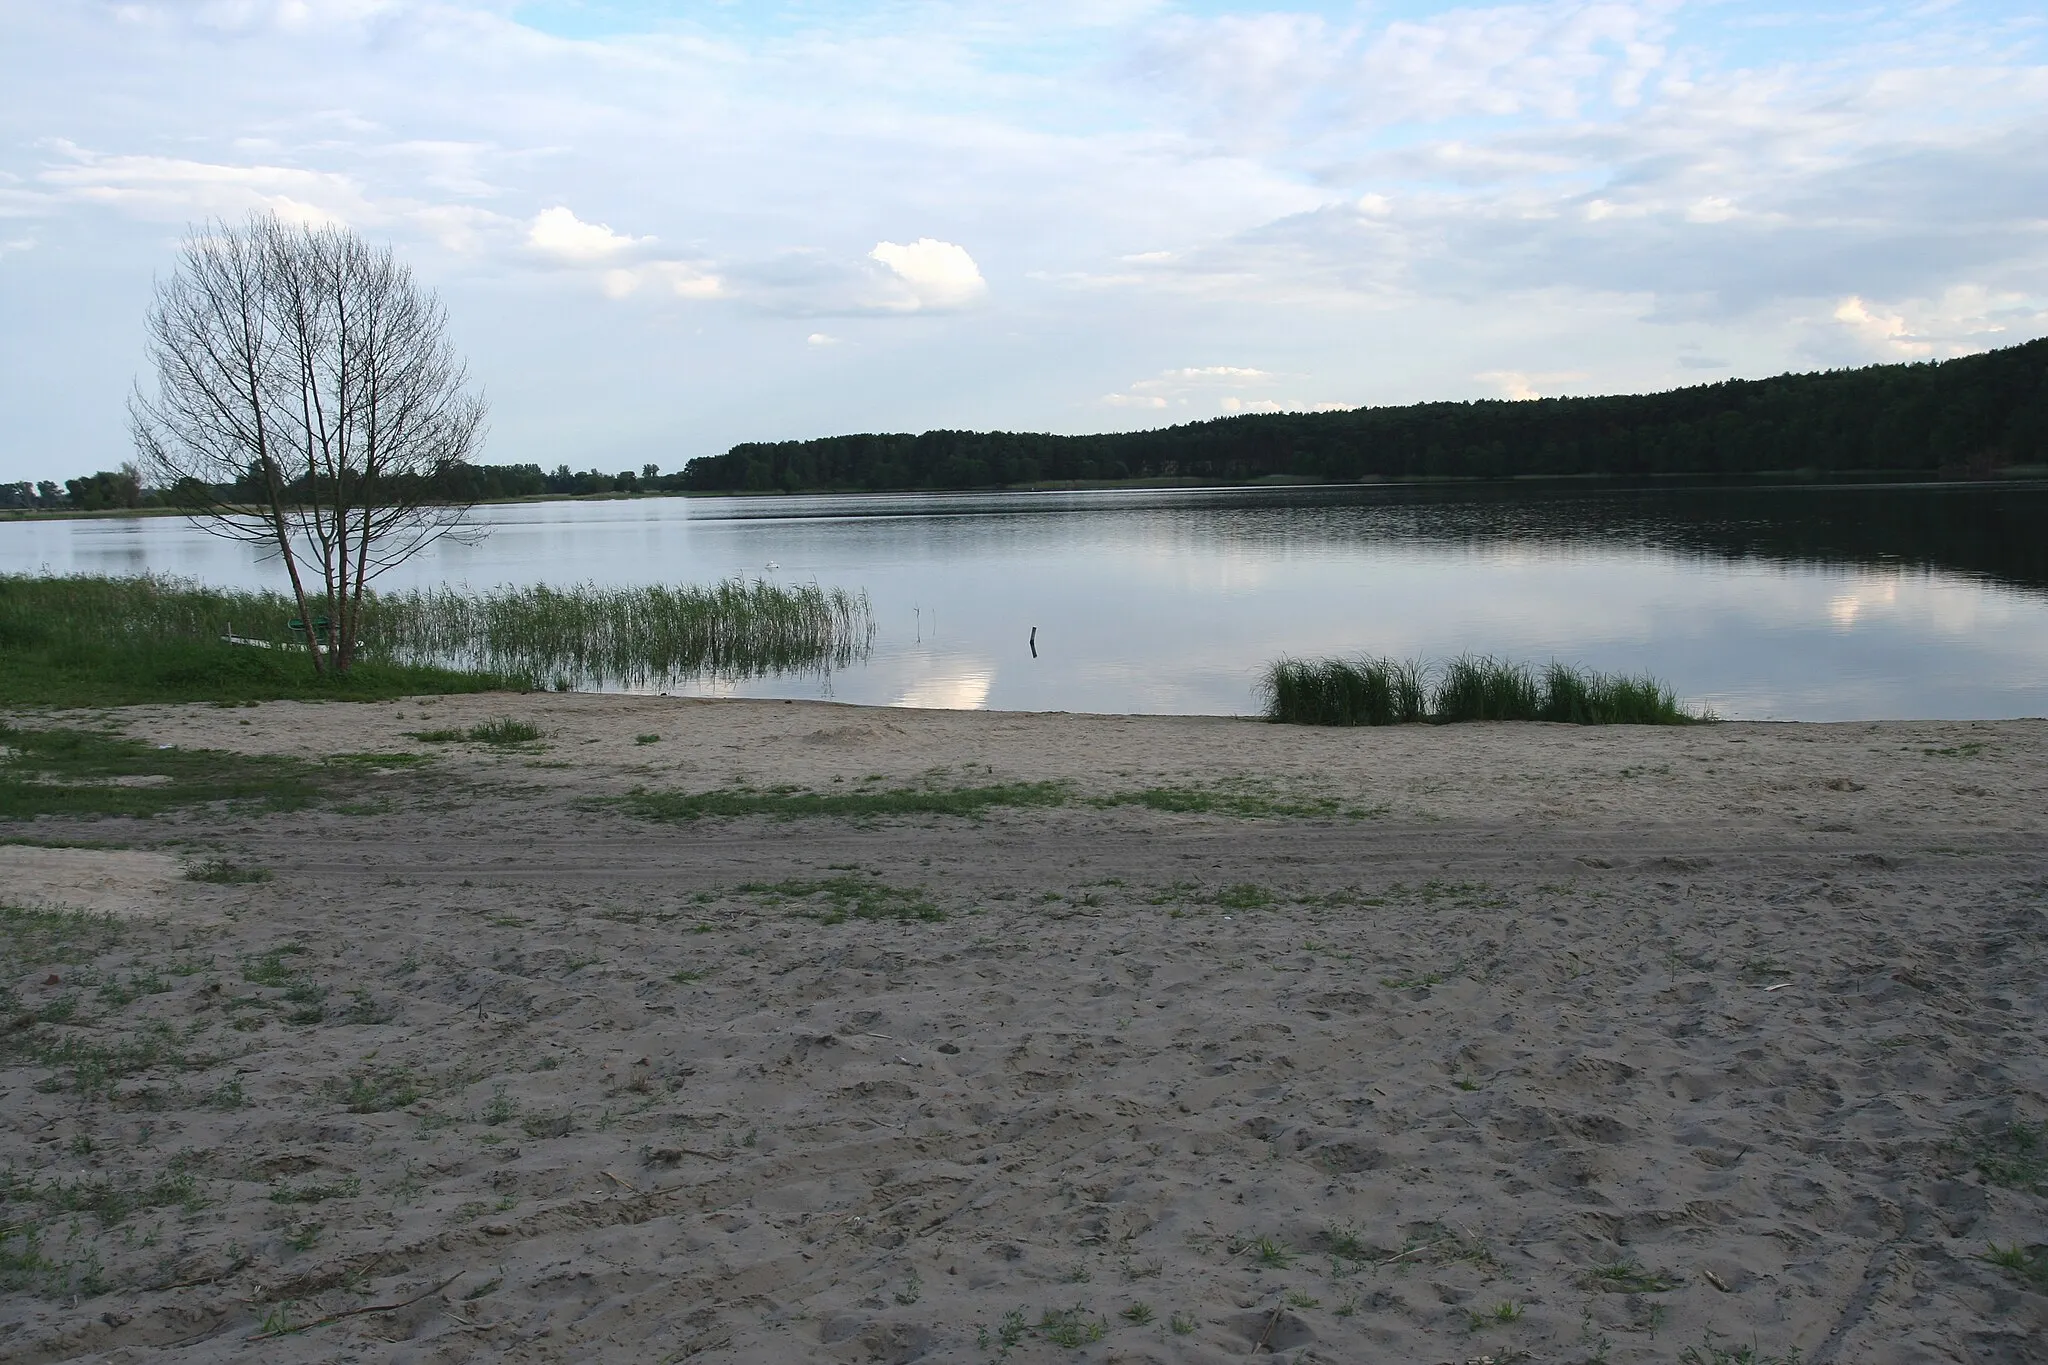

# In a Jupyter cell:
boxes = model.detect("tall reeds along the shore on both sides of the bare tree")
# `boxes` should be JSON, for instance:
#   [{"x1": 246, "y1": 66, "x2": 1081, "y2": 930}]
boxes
[{"x1": 0, "y1": 575, "x2": 874, "y2": 690}]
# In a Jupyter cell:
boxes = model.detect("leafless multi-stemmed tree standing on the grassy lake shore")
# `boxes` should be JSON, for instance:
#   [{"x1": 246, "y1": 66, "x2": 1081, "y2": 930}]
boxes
[{"x1": 129, "y1": 213, "x2": 485, "y2": 673}]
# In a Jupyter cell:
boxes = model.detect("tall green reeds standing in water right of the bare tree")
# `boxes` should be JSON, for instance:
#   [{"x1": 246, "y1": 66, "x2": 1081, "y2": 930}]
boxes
[{"x1": 365, "y1": 579, "x2": 874, "y2": 686}]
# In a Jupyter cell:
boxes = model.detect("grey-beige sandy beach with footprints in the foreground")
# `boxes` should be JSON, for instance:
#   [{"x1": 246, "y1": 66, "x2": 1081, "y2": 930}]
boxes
[{"x1": 0, "y1": 696, "x2": 2048, "y2": 1365}]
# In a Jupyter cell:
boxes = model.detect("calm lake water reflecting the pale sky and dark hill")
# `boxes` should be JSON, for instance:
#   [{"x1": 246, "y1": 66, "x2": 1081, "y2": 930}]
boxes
[{"x1": 0, "y1": 481, "x2": 2048, "y2": 720}]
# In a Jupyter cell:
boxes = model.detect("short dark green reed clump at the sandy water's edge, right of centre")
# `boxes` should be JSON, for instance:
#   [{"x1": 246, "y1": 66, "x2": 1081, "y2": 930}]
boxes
[{"x1": 1260, "y1": 655, "x2": 1712, "y2": 724}]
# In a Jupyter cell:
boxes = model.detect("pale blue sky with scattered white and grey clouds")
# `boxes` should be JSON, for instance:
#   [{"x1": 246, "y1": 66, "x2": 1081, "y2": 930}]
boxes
[{"x1": 0, "y1": 0, "x2": 2048, "y2": 479}]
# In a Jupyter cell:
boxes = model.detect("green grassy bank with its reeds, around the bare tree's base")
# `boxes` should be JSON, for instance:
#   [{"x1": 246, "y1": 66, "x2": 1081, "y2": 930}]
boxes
[{"x1": 0, "y1": 575, "x2": 872, "y2": 706}]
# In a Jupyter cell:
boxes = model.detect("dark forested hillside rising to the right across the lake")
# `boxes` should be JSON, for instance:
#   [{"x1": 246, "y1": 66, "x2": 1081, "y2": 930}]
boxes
[{"x1": 680, "y1": 340, "x2": 2048, "y2": 493}]
